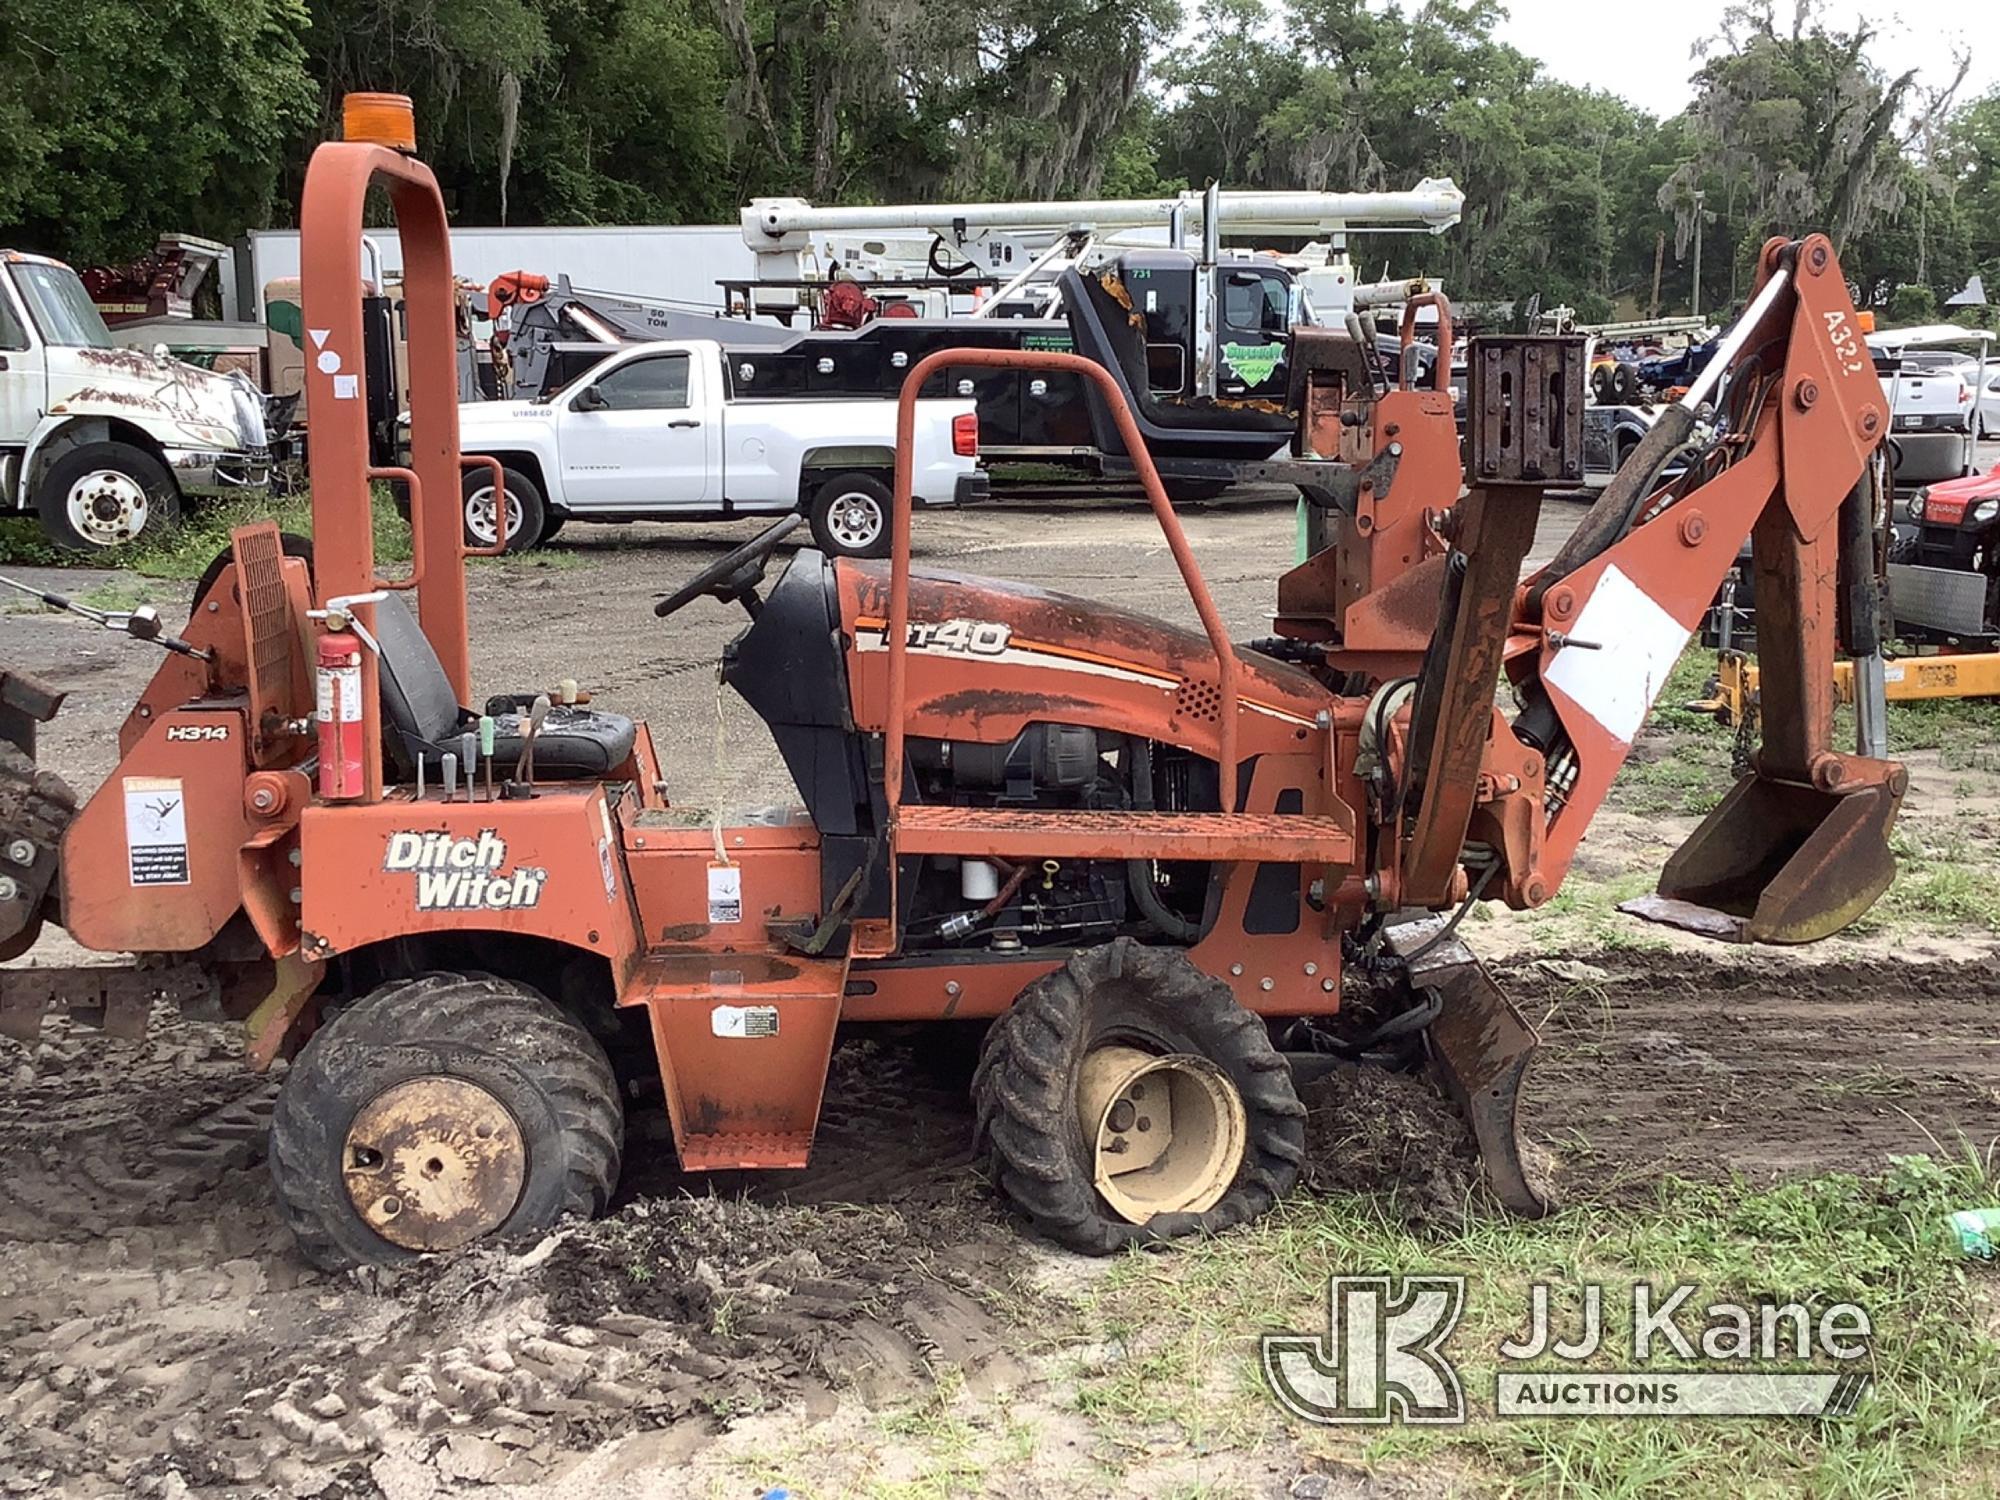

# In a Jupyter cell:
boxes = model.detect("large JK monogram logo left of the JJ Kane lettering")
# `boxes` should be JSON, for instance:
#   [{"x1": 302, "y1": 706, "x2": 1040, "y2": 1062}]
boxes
[{"x1": 1262, "y1": 1276, "x2": 1466, "y2": 1424}]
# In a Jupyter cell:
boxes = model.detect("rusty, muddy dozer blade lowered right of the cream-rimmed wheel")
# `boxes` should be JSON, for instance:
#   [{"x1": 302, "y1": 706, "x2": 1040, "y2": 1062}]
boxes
[{"x1": 1388, "y1": 922, "x2": 1548, "y2": 1218}]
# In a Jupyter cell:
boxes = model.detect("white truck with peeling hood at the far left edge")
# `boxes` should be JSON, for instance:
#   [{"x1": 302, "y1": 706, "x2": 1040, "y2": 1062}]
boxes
[{"x1": 0, "y1": 250, "x2": 270, "y2": 552}]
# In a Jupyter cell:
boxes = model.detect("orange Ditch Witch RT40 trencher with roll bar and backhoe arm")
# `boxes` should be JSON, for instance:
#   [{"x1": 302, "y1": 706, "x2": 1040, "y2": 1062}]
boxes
[{"x1": 0, "y1": 100, "x2": 1904, "y2": 1266}]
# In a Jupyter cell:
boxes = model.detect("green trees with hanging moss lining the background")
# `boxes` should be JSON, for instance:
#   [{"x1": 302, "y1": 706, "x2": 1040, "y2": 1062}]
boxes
[{"x1": 0, "y1": 0, "x2": 2000, "y2": 320}]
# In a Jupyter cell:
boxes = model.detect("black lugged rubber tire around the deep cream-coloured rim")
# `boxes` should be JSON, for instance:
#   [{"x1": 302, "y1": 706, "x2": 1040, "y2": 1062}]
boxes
[{"x1": 972, "y1": 938, "x2": 1306, "y2": 1256}]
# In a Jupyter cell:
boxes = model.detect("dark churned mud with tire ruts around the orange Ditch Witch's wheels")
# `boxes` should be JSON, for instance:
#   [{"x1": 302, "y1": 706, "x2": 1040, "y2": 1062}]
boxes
[{"x1": 0, "y1": 956, "x2": 2000, "y2": 1500}]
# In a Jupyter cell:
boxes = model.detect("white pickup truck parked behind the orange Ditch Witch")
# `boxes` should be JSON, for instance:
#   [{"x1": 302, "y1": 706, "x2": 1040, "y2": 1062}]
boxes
[{"x1": 458, "y1": 340, "x2": 986, "y2": 558}]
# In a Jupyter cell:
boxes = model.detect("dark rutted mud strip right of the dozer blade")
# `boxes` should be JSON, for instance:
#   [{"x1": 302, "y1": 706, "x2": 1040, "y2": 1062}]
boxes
[{"x1": 1498, "y1": 954, "x2": 2000, "y2": 1198}]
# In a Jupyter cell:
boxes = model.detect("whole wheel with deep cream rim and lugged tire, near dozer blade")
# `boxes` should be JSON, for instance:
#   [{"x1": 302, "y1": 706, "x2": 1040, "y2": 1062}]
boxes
[{"x1": 972, "y1": 938, "x2": 1306, "y2": 1256}]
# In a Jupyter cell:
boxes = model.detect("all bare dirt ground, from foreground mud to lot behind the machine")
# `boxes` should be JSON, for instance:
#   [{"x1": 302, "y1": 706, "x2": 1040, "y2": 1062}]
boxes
[{"x1": 0, "y1": 490, "x2": 2000, "y2": 1500}]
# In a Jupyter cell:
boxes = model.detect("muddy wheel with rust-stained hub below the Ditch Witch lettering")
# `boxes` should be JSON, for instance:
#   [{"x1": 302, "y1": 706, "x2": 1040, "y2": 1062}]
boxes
[{"x1": 270, "y1": 974, "x2": 624, "y2": 1270}]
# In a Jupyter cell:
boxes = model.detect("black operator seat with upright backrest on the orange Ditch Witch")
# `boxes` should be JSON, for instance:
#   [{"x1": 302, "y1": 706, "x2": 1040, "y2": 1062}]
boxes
[{"x1": 376, "y1": 594, "x2": 638, "y2": 780}]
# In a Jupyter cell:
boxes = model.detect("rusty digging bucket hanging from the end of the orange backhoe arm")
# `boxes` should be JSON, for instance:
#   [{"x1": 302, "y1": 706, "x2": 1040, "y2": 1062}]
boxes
[{"x1": 1620, "y1": 758, "x2": 1906, "y2": 942}]
